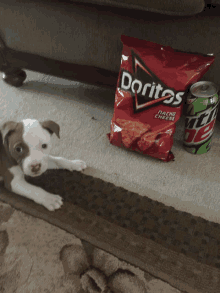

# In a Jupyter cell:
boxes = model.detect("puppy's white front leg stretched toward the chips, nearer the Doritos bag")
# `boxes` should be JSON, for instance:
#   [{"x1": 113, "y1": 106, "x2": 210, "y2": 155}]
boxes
[{"x1": 49, "y1": 156, "x2": 86, "y2": 171}]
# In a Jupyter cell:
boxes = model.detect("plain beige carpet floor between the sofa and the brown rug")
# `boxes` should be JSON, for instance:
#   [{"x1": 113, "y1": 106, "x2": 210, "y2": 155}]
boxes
[{"x1": 0, "y1": 71, "x2": 220, "y2": 223}]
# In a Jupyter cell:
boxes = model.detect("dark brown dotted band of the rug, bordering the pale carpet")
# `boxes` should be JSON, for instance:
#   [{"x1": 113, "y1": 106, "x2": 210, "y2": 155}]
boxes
[{"x1": 27, "y1": 170, "x2": 220, "y2": 269}]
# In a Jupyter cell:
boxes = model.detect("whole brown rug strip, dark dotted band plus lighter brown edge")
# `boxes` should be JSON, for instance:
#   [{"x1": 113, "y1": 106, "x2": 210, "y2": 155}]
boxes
[{"x1": 0, "y1": 170, "x2": 220, "y2": 293}]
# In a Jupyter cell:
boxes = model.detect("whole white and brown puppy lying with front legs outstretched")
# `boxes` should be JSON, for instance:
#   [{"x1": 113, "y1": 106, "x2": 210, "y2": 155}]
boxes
[{"x1": 0, "y1": 119, "x2": 86, "y2": 211}]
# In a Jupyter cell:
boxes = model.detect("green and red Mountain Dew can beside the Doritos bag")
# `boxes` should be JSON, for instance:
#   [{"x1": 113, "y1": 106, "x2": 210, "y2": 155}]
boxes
[{"x1": 183, "y1": 81, "x2": 219, "y2": 154}]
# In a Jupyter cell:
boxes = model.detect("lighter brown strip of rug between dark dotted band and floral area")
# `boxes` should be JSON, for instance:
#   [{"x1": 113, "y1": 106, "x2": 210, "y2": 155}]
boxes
[{"x1": 0, "y1": 187, "x2": 220, "y2": 293}]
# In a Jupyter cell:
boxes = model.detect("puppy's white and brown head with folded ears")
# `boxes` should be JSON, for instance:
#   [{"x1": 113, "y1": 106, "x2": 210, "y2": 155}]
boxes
[{"x1": 1, "y1": 119, "x2": 60, "y2": 177}]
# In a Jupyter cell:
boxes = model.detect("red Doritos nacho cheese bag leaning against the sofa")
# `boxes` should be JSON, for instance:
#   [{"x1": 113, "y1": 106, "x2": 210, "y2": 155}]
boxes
[{"x1": 108, "y1": 36, "x2": 215, "y2": 162}]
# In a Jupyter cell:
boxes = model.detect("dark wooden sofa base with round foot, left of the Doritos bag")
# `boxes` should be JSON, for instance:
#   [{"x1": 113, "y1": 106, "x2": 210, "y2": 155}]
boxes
[{"x1": 0, "y1": 48, "x2": 118, "y2": 90}]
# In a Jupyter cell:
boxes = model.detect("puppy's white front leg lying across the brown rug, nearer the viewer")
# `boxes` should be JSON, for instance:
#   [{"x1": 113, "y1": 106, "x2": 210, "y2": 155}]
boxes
[{"x1": 5, "y1": 167, "x2": 63, "y2": 211}]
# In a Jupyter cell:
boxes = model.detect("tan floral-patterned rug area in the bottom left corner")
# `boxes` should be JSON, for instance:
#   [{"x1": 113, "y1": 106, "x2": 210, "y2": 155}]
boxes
[{"x1": 0, "y1": 202, "x2": 160, "y2": 293}]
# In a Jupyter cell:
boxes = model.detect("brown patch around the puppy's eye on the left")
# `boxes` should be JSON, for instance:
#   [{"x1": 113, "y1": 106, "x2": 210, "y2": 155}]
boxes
[{"x1": 3, "y1": 122, "x2": 29, "y2": 168}]
